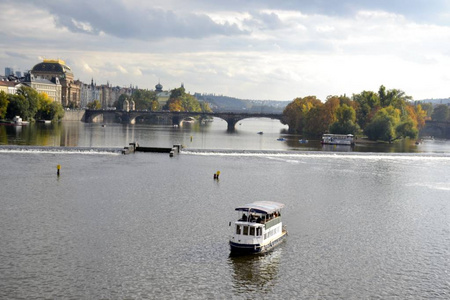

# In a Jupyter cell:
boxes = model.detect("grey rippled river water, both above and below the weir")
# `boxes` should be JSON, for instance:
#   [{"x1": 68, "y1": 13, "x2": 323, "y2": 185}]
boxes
[{"x1": 0, "y1": 120, "x2": 450, "y2": 299}]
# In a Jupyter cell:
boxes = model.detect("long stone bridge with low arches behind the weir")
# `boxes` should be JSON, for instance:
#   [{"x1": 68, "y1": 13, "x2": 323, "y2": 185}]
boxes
[{"x1": 84, "y1": 109, "x2": 283, "y2": 131}]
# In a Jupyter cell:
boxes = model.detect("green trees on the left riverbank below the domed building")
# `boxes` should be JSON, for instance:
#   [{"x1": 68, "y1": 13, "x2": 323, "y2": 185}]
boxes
[{"x1": 0, "y1": 86, "x2": 64, "y2": 121}]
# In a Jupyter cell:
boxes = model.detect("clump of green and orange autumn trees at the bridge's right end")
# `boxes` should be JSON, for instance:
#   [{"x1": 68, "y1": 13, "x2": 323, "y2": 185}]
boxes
[{"x1": 282, "y1": 85, "x2": 438, "y2": 141}]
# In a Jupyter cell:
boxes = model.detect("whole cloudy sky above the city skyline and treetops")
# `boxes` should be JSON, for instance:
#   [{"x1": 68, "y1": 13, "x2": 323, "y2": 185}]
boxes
[{"x1": 0, "y1": 0, "x2": 450, "y2": 100}]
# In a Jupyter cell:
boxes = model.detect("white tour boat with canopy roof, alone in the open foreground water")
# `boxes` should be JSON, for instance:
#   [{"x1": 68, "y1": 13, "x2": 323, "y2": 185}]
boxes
[{"x1": 230, "y1": 201, "x2": 287, "y2": 254}]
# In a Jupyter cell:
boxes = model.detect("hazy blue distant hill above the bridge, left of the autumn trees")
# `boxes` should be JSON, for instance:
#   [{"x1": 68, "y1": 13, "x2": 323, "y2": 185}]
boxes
[{"x1": 194, "y1": 93, "x2": 292, "y2": 113}]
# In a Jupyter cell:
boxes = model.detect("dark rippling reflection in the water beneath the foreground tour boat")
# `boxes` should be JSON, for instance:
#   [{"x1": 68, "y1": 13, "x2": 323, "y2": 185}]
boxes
[{"x1": 228, "y1": 247, "x2": 282, "y2": 294}]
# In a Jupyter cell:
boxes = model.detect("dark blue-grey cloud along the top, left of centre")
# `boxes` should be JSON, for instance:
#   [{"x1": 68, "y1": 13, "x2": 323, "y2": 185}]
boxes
[{"x1": 42, "y1": 0, "x2": 247, "y2": 40}]
